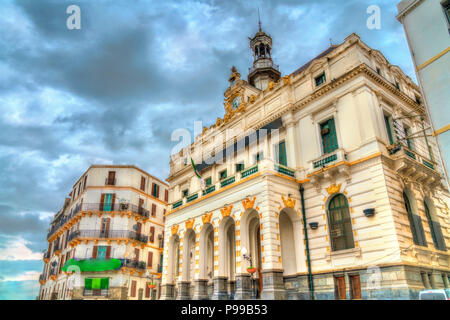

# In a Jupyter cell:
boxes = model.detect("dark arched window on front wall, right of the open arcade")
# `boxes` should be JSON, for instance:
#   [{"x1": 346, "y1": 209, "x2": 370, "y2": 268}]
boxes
[{"x1": 328, "y1": 194, "x2": 355, "y2": 251}]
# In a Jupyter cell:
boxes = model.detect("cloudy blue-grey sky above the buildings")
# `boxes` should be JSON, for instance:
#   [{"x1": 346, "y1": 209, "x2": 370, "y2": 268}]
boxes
[{"x1": 0, "y1": 0, "x2": 415, "y2": 299}]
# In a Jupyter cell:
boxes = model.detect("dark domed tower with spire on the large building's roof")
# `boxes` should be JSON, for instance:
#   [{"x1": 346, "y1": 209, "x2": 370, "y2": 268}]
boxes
[{"x1": 248, "y1": 10, "x2": 281, "y2": 90}]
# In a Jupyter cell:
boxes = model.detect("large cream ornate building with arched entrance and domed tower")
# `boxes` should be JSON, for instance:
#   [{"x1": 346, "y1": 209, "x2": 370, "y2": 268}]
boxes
[{"x1": 161, "y1": 30, "x2": 450, "y2": 299}]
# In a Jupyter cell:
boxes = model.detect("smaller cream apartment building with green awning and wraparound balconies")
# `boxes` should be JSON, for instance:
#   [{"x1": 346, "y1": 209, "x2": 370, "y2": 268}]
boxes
[{"x1": 39, "y1": 165, "x2": 168, "y2": 299}]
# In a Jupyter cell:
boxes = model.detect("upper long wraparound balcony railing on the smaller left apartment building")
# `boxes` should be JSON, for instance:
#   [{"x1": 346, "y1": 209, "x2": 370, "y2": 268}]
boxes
[{"x1": 47, "y1": 203, "x2": 150, "y2": 238}]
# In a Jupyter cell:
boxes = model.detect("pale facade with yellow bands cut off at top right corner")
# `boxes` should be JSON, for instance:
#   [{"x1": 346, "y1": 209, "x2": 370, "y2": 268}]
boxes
[{"x1": 397, "y1": 0, "x2": 450, "y2": 179}]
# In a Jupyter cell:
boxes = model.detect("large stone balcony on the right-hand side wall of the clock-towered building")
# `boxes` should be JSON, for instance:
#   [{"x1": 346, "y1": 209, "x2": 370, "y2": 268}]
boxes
[{"x1": 388, "y1": 143, "x2": 445, "y2": 189}]
